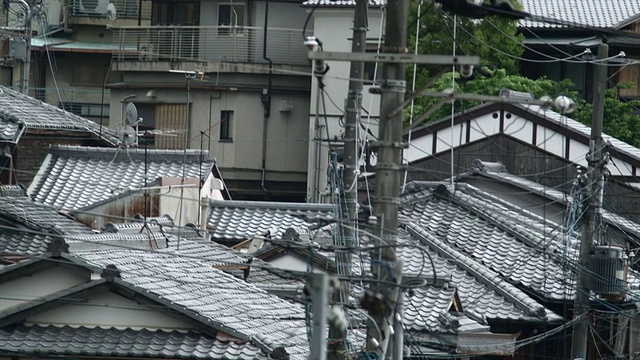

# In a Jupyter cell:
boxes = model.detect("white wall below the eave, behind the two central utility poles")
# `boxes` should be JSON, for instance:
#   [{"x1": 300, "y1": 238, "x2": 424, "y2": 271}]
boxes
[{"x1": 307, "y1": 9, "x2": 383, "y2": 201}]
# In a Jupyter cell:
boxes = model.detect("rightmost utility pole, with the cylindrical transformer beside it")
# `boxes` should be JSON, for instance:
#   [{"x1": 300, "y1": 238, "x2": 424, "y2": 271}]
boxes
[{"x1": 571, "y1": 40, "x2": 609, "y2": 359}]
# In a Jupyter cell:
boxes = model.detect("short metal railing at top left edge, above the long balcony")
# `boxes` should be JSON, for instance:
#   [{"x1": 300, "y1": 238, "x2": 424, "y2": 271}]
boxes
[{"x1": 67, "y1": 0, "x2": 151, "y2": 21}]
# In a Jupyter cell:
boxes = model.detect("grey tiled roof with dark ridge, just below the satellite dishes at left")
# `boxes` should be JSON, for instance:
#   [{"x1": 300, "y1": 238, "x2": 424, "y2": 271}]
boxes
[{"x1": 29, "y1": 146, "x2": 213, "y2": 210}]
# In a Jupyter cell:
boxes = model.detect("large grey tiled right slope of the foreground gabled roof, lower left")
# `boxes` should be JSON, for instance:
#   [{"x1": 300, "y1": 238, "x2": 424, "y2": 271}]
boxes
[{"x1": 76, "y1": 245, "x2": 309, "y2": 360}]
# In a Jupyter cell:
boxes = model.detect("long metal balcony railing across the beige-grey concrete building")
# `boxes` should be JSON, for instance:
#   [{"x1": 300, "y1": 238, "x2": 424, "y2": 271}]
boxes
[{"x1": 112, "y1": 26, "x2": 308, "y2": 65}]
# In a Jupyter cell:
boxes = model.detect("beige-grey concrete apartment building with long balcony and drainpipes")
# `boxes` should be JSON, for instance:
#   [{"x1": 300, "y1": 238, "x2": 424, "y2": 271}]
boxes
[{"x1": 109, "y1": 1, "x2": 313, "y2": 201}]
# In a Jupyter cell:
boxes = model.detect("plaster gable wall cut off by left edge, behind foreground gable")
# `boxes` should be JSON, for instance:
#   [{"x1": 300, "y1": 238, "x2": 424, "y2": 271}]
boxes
[{"x1": 0, "y1": 266, "x2": 89, "y2": 311}]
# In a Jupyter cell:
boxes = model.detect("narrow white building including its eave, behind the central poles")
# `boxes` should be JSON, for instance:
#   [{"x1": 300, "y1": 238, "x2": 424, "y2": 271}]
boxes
[{"x1": 305, "y1": 0, "x2": 385, "y2": 202}]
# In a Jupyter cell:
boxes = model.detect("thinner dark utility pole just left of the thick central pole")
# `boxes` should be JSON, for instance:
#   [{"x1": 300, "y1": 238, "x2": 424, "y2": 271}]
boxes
[{"x1": 327, "y1": 0, "x2": 368, "y2": 360}]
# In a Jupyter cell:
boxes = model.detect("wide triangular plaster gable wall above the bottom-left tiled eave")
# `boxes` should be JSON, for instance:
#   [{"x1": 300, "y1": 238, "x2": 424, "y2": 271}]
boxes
[{"x1": 25, "y1": 292, "x2": 193, "y2": 329}]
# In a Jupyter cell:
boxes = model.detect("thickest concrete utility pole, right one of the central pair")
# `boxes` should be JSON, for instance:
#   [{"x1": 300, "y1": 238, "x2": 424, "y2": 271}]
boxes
[{"x1": 367, "y1": 0, "x2": 409, "y2": 356}]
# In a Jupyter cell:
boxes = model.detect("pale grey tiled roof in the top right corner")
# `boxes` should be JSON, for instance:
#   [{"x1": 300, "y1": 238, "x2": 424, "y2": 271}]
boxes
[{"x1": 520, "y1": 0, "x2": 640, "y2": 29}]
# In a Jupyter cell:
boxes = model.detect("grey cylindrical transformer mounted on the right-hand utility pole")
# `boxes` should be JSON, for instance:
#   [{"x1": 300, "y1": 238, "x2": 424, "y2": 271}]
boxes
[{"x1": 589, "y1": 246, "x2": 627, "y2": 299}]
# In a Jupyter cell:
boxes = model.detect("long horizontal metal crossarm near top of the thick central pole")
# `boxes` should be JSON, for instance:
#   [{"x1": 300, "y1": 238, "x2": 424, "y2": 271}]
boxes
[{"x1": 307, "y1": 51, "x2": 480, "y2": 66}]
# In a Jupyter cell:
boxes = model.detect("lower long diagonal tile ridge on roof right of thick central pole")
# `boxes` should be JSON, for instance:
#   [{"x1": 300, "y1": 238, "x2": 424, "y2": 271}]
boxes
[{"x1": 407, "y1": 224, "x2": 546, "y2": 317}]
